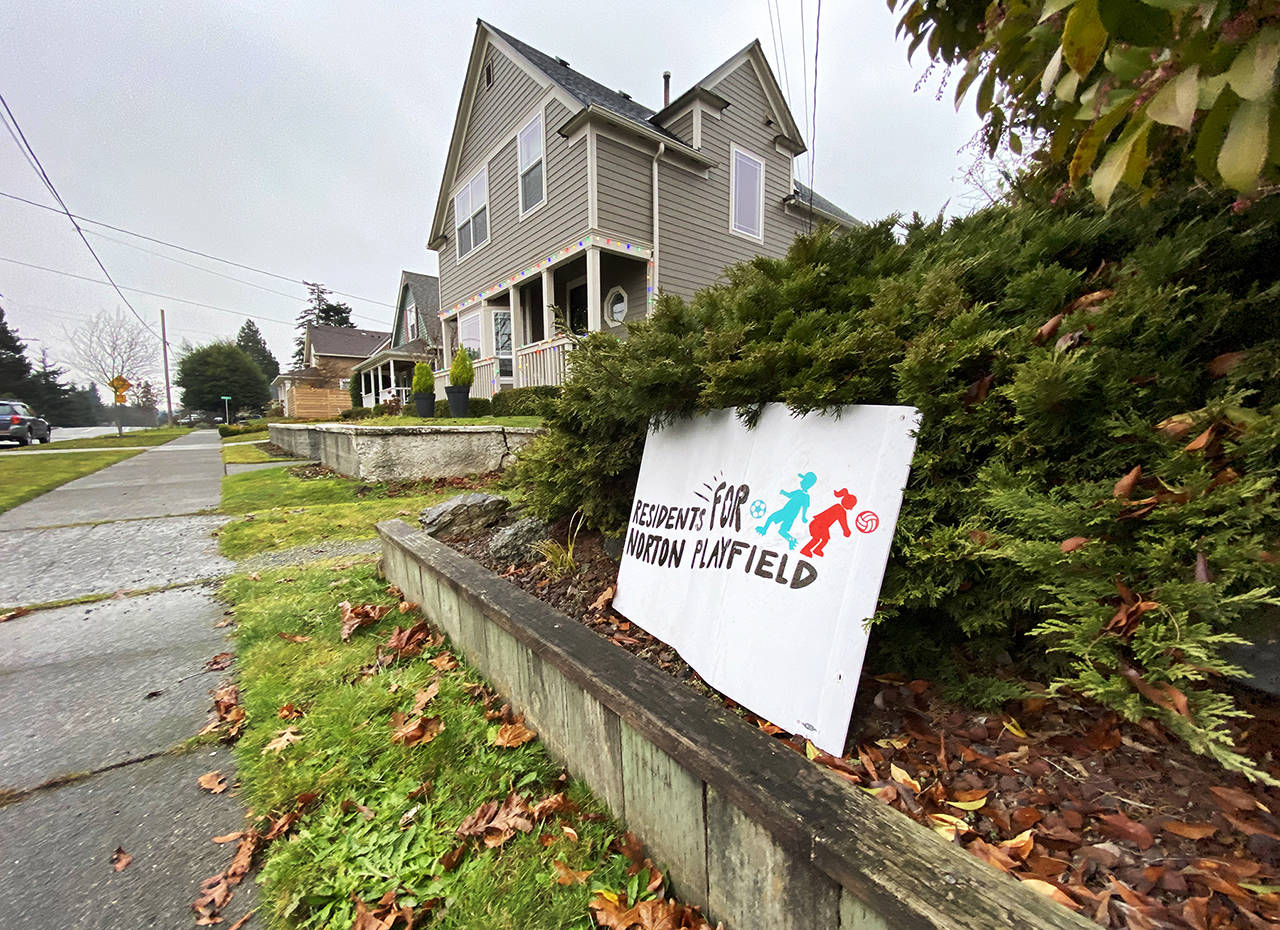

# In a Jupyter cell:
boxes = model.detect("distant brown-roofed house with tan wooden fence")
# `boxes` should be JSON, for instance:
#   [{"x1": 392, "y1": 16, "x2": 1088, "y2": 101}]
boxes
[{"x1": 271, "y1": 325, "x2": 390, "y2": 420}]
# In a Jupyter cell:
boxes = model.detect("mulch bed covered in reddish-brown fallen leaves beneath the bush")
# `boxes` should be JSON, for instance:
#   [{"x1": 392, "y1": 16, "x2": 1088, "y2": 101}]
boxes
[{"x1": 443, "y1": 523, "x2": 1280, "y2": 930}]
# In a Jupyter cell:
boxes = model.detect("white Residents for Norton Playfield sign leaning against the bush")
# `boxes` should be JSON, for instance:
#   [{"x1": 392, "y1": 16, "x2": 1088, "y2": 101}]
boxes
[{"x1": 613, "y1": 404, "x2": 919, "y2": 755}]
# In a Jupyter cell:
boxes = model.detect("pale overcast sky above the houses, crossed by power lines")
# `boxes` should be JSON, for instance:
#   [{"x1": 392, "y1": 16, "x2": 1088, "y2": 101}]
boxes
[{"x1": 0, "y1": 0, "x2": 978, "y2": 394}]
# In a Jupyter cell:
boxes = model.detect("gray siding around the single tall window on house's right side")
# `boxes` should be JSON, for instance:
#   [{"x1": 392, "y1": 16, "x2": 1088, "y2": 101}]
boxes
[{"x1": 658, "y1": 61, "x2": 801, "y2": 298}]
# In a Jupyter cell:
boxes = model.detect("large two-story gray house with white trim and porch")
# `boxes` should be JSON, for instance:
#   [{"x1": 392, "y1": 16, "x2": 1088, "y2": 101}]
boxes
[{"x1": 428, "y1": 20, "x2": 858, "y2": 397}]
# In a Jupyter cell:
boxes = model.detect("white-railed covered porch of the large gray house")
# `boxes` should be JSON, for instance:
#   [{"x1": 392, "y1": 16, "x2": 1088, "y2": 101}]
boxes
[{"x1": 435, "y1": 237, "x2": 652, "y2": 398}]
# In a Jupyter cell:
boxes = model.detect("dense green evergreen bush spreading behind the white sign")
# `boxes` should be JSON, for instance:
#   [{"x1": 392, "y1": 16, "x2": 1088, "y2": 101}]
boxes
[{"x1": 512, "y1": 193, "x2": 1280, "y2": 778}]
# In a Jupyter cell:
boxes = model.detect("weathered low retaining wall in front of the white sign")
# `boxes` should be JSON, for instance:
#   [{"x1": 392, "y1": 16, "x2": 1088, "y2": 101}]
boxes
[{"x1": 378, "y1": 521, "x2": 1096, "y2": 930}]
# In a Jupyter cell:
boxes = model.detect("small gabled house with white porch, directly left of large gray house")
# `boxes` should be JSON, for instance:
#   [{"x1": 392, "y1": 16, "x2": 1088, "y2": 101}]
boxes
[{"x1": 352, "y1": 271, "x2": 444, "y2": 407}]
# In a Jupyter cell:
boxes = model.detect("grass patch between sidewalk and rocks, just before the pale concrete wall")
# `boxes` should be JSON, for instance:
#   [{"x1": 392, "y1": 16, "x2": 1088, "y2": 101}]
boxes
[{"x1": 218, "y1": 465, "x2": 462, "y2": 559}]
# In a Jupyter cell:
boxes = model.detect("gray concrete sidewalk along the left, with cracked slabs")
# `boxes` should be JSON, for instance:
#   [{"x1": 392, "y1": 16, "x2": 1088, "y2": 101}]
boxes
[{"x1": 0, "y1": 431, "x2": 253, "y2": 930}]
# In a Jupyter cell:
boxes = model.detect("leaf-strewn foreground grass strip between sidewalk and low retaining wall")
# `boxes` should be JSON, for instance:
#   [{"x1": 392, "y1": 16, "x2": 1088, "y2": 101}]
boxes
[{"x1": 223, "y1": 562, "x2": 645, "y2": 930}]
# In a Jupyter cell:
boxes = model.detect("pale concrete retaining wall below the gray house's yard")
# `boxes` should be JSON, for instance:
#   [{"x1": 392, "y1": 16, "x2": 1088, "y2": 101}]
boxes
[{"x1": 268, "y1": 423, "x2": 540, "y2": 481}]
